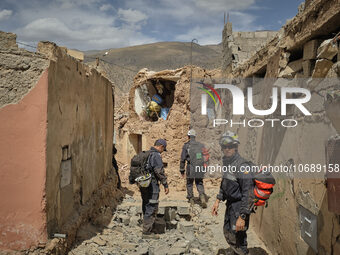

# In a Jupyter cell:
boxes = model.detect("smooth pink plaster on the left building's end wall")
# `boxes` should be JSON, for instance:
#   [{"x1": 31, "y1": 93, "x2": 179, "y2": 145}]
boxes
[{"x1": 0, "y1": 70, "x2": 48, "y2": 250}]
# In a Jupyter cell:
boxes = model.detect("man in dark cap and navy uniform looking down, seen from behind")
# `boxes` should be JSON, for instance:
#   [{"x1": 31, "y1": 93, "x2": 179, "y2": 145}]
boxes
[{"x1": 140, "y1": 139, "x2": 169, "y2": 239}]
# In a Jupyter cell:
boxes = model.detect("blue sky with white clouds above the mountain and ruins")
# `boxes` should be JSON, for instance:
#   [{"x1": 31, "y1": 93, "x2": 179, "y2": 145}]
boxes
[{"x1": 0, "y1": 0, "x2": 303, "y2": 50}]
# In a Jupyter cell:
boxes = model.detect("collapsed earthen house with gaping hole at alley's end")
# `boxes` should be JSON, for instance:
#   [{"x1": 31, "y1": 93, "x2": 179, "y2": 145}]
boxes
[{"x1": 115, "y1": 66, "x2": 221, "y2": 185}]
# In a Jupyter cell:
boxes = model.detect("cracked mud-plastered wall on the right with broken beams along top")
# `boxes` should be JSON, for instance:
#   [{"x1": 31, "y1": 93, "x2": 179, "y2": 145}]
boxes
[{"x1": 220, "y1": 0, "x2": 340, "y2": 254}]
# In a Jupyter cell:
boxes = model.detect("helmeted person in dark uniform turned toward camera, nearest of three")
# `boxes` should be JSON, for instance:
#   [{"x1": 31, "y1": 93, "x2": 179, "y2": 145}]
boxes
[{"x1": 212, "y1": 131, "x2": 254, "y2": 255}]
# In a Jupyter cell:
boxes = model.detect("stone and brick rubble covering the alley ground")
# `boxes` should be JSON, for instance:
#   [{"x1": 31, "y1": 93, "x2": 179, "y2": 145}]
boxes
[{"x1": 68, "y1": 195, "x2": 266, "y2": 255}]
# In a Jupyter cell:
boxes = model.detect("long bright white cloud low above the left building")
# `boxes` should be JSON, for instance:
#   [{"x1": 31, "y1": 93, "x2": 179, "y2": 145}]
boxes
[{"x1": 16, "y1": 15, "x2": 155, "y2": 50}]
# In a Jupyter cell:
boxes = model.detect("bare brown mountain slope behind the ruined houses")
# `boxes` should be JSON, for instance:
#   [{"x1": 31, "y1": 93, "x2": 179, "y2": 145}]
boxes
[{"x1": 84, "y1": 42, "x2": 222, "y2": 93}]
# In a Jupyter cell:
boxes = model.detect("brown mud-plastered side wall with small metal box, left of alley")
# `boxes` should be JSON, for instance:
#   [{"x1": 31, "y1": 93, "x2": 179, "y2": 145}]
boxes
[{"x1": 46, "y1": 42, "x2": 113, "y2": 233}]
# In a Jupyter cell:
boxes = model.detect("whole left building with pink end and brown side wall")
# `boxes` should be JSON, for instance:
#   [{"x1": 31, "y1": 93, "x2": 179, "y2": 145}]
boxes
[{"x1": 0, "y1": 32, "x2": 119, "y2": 254}]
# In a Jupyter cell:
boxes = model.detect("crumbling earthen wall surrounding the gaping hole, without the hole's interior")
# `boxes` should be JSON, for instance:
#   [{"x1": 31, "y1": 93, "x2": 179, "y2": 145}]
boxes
[{"x1": 116, "y1": 66, "x2": 221, "y2": 186}]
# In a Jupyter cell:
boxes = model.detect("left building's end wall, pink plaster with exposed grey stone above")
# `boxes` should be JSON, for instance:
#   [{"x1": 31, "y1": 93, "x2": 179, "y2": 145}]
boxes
[{"x1": 0, "y1": 36, "x2": 48, "y2": 249}]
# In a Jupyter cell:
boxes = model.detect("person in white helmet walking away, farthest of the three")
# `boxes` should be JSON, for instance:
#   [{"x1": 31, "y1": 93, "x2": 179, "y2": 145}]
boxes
[{"x1": 180, "y1": 129, "x2": 209, "y2": 208}]
